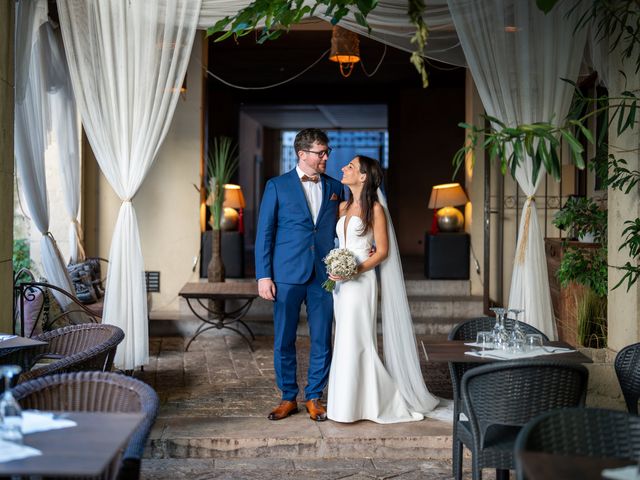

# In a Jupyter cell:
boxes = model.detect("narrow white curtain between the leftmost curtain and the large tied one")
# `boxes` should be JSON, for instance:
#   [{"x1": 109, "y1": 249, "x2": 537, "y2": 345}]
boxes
[{"x1": 47, "y1": 24, "x2": 85, "y2": 263}]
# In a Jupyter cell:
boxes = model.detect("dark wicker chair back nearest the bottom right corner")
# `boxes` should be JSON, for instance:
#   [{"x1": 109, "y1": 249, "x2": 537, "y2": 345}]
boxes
[{"x1": 515, "y1": 408, "x2": 640, "y2": 479}]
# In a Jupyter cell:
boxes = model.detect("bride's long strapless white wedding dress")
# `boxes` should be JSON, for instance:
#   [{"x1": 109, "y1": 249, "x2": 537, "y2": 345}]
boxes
[{"x1": 327, "y1": 212, "x2": 438, "y2": 423}]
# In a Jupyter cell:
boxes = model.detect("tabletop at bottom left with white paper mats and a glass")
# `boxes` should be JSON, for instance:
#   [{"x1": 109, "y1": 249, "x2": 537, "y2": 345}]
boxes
[{"x1": 0, "y1": 412, "x2": 144, "y2": 477}]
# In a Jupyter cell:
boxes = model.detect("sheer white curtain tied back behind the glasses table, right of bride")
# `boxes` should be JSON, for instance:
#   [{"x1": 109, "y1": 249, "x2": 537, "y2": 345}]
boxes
[{"x1": 449, "y1": 0, "x2": 586, "y2": 338}]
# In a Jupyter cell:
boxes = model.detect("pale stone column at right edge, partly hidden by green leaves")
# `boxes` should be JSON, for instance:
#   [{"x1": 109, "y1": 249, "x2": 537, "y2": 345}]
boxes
[{"x1": 607, "y1": 45, "x2": 640, "y2": 351}]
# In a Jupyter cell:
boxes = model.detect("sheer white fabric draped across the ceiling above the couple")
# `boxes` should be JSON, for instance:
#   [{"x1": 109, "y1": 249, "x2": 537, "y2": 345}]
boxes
[{"x1": 198, "y1": 0, "x2": 466, "y2": 66}]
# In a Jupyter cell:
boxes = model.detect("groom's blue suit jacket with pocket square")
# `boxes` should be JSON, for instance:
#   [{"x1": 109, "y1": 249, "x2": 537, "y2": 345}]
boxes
[{"x1": 255, "y1": 168, "x2": 344, "y2": 284}]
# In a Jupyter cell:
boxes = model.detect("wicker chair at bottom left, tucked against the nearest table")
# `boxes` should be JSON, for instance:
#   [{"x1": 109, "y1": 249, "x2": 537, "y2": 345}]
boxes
[{"x1": 13, "y1": 372, "x2": 158, "y2": 480}]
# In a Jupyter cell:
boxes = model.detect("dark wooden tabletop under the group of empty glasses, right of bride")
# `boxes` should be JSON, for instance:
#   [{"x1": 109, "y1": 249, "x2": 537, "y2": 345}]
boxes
[{"x1": 424, "y1": 340, "x2": 593, "y2": 363}]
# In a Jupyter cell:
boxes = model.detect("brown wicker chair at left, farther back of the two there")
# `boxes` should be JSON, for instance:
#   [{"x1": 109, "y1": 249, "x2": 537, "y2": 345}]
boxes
[{"x1": 0, "y1": 323, "x2": 124, "y2": 383}]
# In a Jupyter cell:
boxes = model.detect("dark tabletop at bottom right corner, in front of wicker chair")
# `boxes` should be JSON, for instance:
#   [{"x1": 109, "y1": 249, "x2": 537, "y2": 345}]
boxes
[{"x1": 517, "y1": 452, "x2": 636, "y2": 480}]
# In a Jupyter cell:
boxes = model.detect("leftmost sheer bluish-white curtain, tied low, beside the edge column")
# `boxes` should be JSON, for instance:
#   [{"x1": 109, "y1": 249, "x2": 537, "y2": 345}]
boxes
[{"x1": 15, "y1": 1, "x2": 75, "y2": 309}]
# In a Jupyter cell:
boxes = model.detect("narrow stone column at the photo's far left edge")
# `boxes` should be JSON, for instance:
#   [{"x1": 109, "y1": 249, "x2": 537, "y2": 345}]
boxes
[{"x1": 0, "y1": 0, "x2": 15, "y2": 332}]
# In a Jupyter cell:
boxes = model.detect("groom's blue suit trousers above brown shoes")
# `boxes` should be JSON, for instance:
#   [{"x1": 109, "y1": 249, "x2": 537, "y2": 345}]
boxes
[{"x1": 273, "y1": 273, "x2": 333, "y2": 401}]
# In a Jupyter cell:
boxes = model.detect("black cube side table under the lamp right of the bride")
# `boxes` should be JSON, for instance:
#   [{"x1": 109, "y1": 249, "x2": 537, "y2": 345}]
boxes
[{"x1": 424, "y1": 233, "x2": 470, "y2": 280}]
